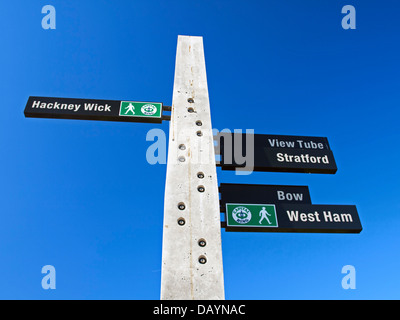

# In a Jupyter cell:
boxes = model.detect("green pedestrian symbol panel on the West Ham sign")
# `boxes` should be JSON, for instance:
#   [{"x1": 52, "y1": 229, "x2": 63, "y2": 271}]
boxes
[{"x1": 226, "y1": 203, "x2": 278, "y2": 227}]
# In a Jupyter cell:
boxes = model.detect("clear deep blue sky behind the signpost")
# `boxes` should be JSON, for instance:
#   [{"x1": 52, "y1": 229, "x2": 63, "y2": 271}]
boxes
[{"x1": 0, "y1": 0, "x2": 400, "y2": 299}]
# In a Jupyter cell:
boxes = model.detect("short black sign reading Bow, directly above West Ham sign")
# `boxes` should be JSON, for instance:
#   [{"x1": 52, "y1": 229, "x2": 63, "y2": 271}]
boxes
[{"x1": 219, "y1": 183, "x2": 311, "y2": 212}]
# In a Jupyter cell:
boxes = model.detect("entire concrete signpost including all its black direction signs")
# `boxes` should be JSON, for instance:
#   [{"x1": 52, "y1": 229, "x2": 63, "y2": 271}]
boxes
[{"x1": 24, "y1": 36, "x2": 362, "y2": 300}]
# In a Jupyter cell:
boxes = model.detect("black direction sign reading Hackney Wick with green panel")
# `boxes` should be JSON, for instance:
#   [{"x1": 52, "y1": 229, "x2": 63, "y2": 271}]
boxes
[{"x1": 24, "y1": 97, "x2": 162, "y2": 123}]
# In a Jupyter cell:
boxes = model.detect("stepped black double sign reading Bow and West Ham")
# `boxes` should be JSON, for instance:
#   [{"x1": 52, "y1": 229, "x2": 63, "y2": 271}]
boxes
[{"x1": 220, "y1": 183, "x2": 362, "y2": 233}]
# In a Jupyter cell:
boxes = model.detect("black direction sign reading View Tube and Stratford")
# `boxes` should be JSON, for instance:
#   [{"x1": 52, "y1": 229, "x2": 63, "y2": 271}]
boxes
[{"x1": 217, "y1": 132, "x2": 337, "y2": 174}]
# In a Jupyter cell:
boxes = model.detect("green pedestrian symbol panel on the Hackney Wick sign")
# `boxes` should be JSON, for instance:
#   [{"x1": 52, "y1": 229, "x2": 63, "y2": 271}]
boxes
[{"x1": 119, "y1": 101, "x2": 162, "y2": 118}]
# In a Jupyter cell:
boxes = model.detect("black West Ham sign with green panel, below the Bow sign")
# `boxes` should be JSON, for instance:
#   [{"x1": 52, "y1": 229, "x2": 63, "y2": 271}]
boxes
[{"x1": 225, "y1": 203, "x2": 362, "y2": 233}]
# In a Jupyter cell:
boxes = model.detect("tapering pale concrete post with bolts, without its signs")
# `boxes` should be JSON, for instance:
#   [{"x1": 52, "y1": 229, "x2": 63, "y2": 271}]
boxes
[{"x1": 161, "y1": 36, "x2": 225, "y2": 300}]
